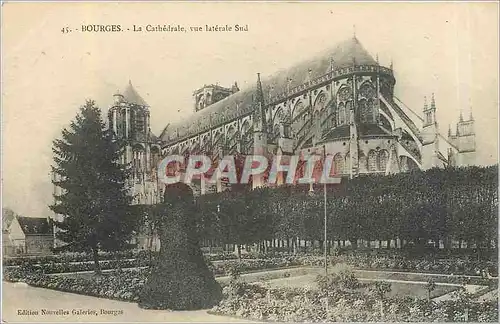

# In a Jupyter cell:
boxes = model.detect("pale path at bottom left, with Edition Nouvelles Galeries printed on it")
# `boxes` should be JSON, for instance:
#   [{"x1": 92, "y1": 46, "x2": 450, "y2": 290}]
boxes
[{"x1": 2, "y1": 282, "x2": 251, "y2": 323}]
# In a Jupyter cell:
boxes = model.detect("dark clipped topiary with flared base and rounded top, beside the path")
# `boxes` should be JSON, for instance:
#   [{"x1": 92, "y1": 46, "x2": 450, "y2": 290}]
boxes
[{"x1": 139, "y1": 183, "x2": 222, "y2": 310}]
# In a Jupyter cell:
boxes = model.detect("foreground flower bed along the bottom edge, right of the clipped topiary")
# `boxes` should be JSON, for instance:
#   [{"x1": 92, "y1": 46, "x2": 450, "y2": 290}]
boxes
[{"x1": 211, "y1": 282, "x2": 498, "y2": 322}]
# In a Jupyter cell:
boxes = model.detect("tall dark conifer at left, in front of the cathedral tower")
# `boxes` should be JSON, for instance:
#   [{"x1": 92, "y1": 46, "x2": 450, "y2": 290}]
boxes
[{"x1": 50, "y1": 100, "x2": 136, "y2": 272}]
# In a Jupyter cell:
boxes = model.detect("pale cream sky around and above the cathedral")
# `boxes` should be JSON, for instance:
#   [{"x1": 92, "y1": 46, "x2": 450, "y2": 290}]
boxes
[{"x1": 2, "y1": 2, "x2": 499, "y2": 217}]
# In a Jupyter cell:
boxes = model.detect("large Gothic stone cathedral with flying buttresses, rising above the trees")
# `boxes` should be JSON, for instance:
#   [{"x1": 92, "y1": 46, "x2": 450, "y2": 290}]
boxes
[{"x1": 108, "y1": 37, "x2": 476, "y2": 204}]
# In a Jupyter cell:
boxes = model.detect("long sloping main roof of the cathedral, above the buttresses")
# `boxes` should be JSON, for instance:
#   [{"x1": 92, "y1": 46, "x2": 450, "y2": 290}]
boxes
[{"x1": 162, "y1": 37, "x2": 377, "y2": 142}]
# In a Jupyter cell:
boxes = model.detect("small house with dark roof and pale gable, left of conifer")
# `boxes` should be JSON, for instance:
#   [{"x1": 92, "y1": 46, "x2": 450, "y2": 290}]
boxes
[{"x1": 9, "y1": 216, "x2": 54, "y2": 255}]
